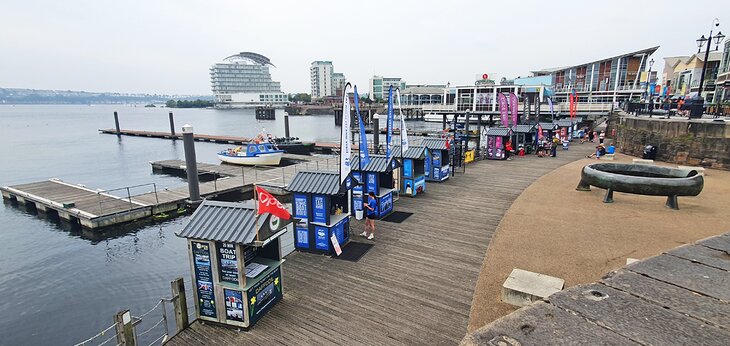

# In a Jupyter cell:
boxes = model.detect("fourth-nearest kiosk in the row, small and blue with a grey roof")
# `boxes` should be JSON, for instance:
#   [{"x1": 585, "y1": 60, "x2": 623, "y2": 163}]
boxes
[{"x1": 393, "y1": 145, "x2": 429, "y2": 197}]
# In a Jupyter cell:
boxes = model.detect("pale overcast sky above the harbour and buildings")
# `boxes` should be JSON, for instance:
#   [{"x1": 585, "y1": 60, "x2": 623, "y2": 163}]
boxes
[{"x1": 0, "y1": 0, "x2": 730, "y2": 95}]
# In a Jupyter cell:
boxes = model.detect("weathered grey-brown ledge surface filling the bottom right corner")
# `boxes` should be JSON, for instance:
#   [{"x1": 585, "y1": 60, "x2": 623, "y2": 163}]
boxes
[{"x1": 462, "y1": 233, "x2": 730, "y2": 345}]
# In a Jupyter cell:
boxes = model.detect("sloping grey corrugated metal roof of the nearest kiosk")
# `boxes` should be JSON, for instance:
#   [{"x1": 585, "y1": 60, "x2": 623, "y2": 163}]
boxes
[{"x1": 176, "y1": 200, "x2": 256, "y2": 244}]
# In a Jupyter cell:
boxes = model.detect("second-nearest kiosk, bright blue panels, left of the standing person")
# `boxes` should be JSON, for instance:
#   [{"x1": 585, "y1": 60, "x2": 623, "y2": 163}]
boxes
[{"x1": 286, "y1": 171, "x2": 352, "y2": 255}]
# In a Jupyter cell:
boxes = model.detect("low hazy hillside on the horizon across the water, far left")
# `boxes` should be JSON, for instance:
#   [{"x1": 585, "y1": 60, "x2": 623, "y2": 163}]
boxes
[{"x1": 0, "y1": 88, "x2": 213, "y2": 104}]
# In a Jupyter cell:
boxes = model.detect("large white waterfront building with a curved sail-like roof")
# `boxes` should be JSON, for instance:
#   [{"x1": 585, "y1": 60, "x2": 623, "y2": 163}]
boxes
[{"x1": 210, "y1": 52, "x2": 288, "y2": 108}]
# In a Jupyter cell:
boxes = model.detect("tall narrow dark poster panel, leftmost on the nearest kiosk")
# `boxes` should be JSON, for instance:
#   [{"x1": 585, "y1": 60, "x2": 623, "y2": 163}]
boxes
[{"x1": 190, "y1": 241, "x2": 217, "y2": 318}]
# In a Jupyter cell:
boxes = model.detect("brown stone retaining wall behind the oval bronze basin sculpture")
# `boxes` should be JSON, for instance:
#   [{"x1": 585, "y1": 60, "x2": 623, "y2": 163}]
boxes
[{"x1": 607, "y1": 115, "x2": 730, "y2": 170}]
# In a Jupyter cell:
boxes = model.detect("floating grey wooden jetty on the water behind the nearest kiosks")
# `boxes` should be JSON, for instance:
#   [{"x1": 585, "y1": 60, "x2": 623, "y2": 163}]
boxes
[{"x1": 0, "y1": 154, "x2": 339, "y2": 229}]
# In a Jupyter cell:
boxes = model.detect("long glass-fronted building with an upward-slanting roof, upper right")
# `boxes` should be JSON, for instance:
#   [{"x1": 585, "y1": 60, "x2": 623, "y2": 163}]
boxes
[{"x1": 532, "y1": 46, "x2": 659, "y2": 104}]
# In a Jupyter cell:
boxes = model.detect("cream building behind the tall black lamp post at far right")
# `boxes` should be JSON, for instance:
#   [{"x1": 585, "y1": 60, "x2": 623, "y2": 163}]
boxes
[{"x1": 663, "y1": 52, "x2": 723, "y2": 103}]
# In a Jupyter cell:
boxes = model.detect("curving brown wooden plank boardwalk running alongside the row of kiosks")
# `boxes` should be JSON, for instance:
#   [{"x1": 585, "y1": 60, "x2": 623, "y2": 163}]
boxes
[{"x1": 168, "y1": 145, "x2": 592, "y2": 345}]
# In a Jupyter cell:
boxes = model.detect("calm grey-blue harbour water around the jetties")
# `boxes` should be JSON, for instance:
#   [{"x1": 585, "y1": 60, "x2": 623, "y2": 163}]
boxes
[{"x1": 0, "y1": 105, "x2": 441, "y2": 345}]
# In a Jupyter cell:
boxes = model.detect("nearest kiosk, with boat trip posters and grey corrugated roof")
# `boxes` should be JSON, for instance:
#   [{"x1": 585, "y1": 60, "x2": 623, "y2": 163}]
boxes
[{"x1": 177, "y1": 200, "x2": 286, "y2": 328}]
